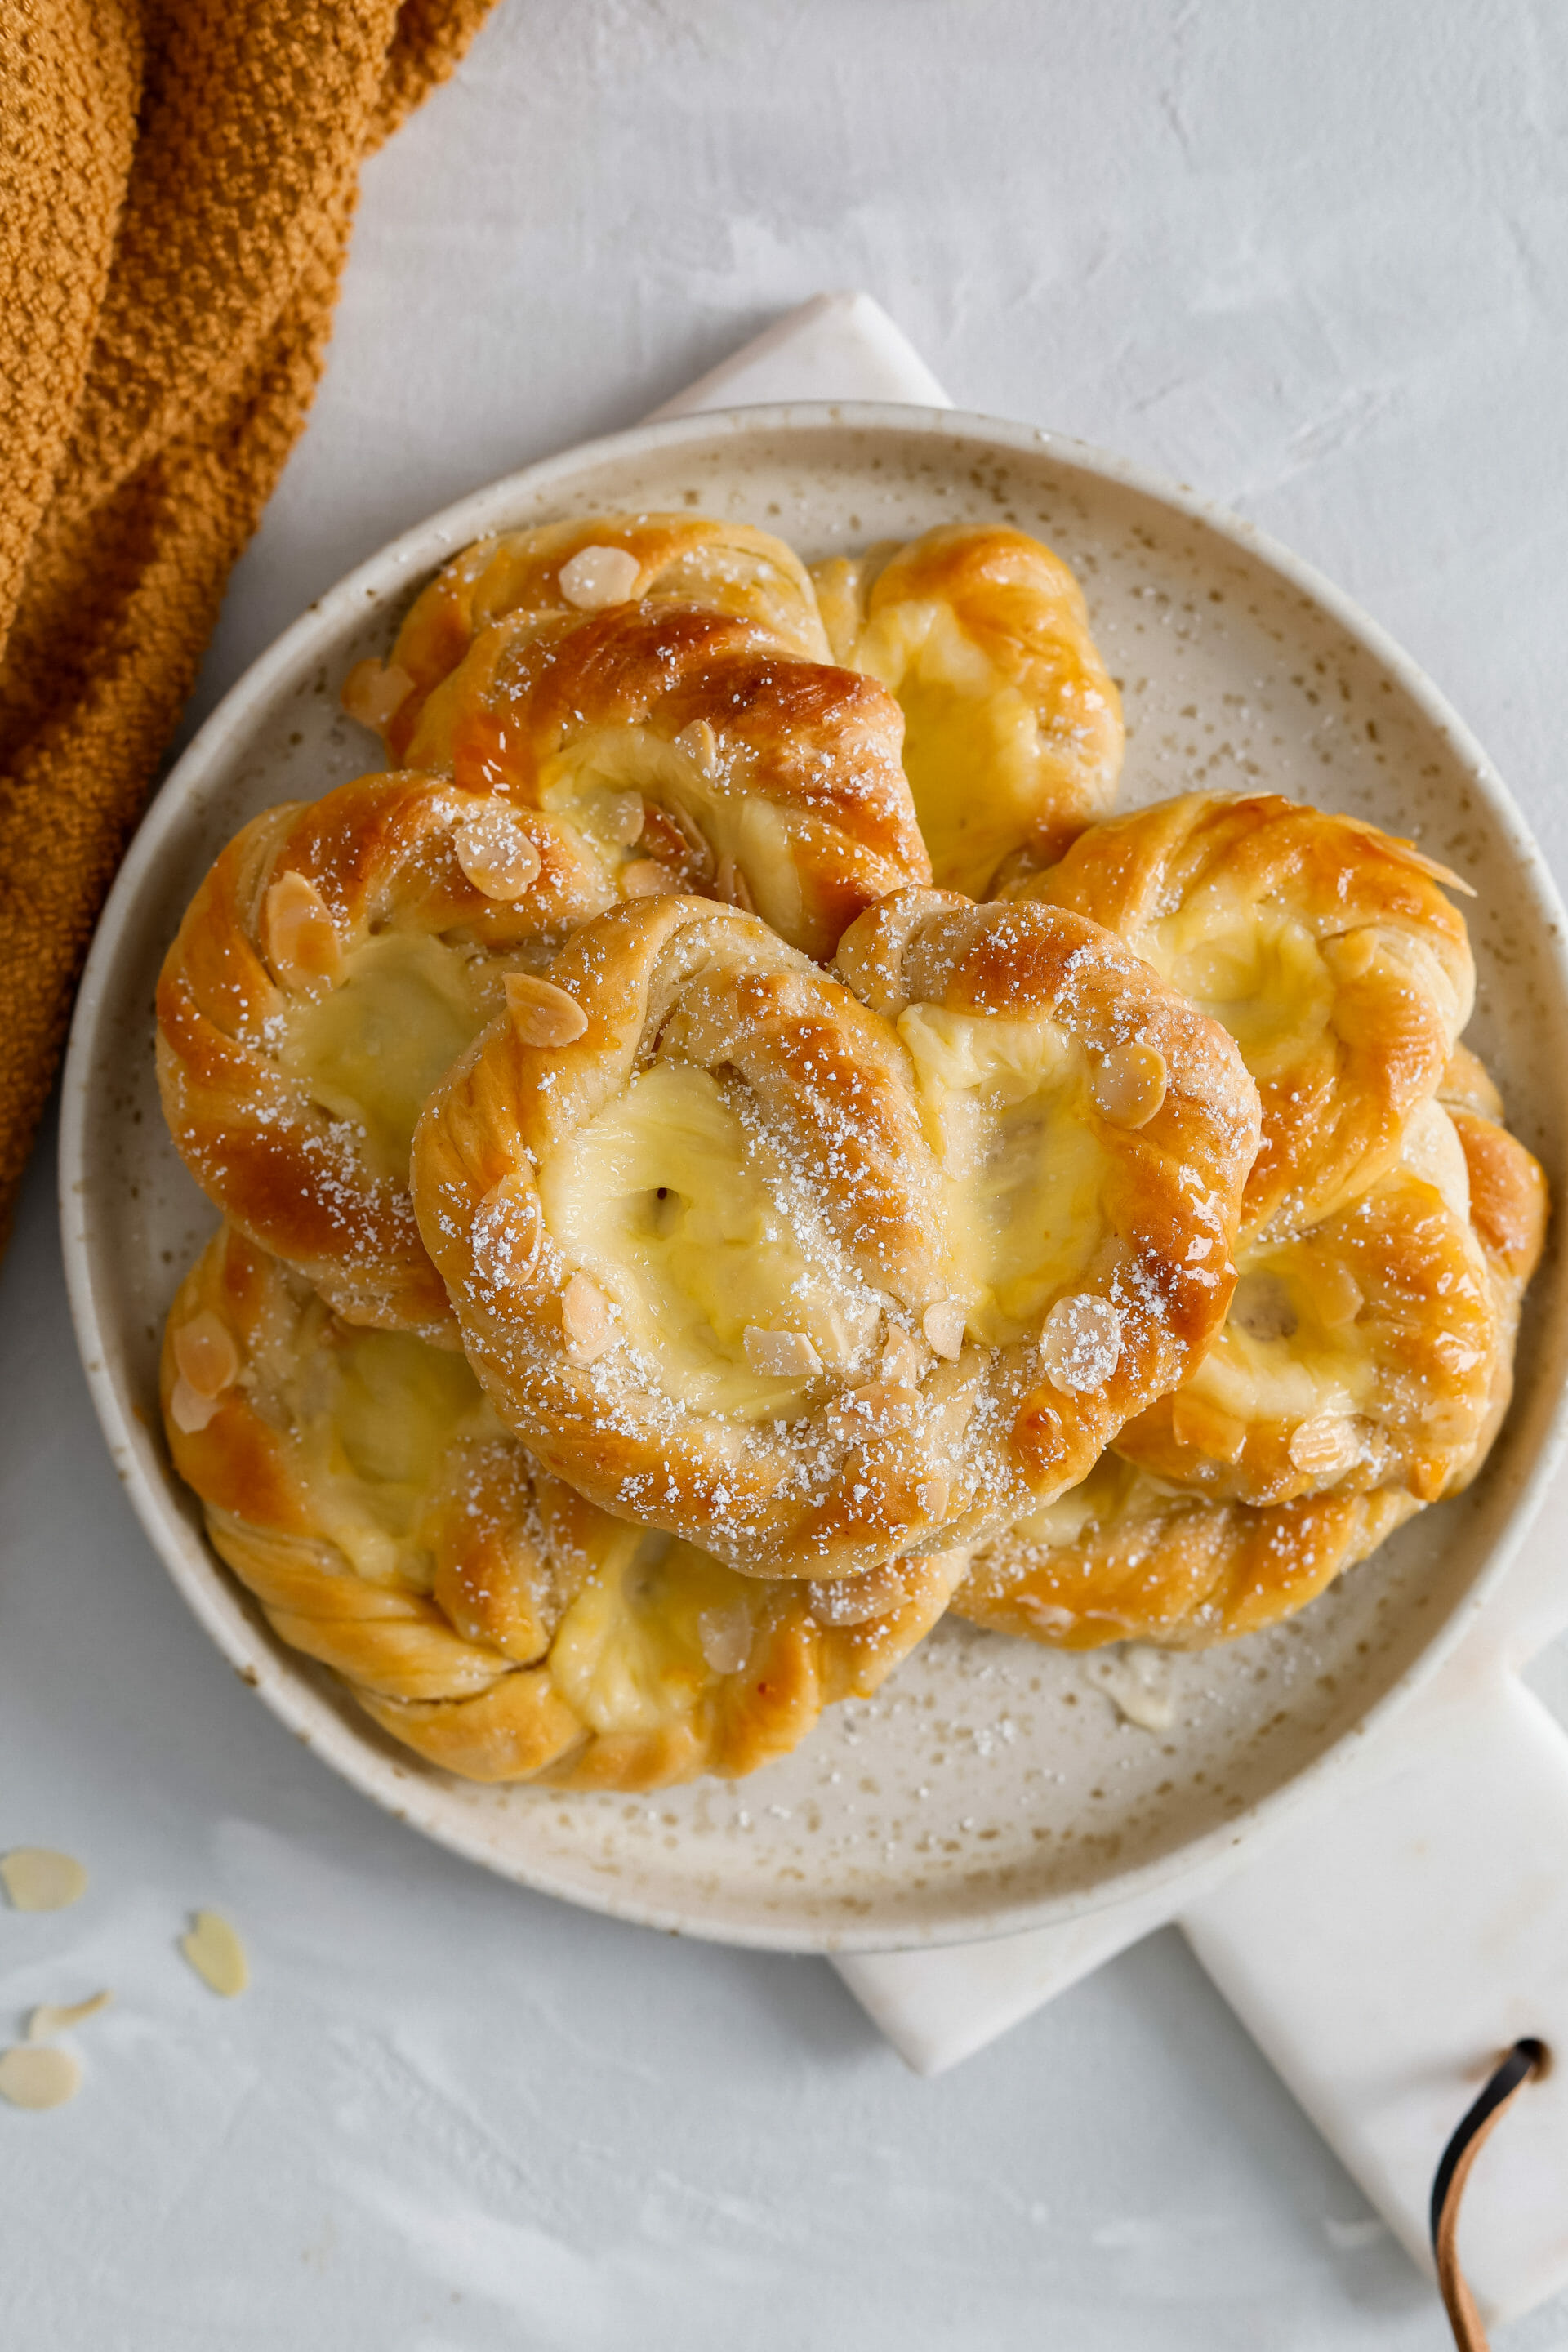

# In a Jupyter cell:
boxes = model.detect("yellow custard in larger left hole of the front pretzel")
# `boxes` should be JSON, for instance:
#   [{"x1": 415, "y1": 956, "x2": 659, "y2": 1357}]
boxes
[{"x1": 538, "y1": 1061, "x2": 880, "y2": 1419}]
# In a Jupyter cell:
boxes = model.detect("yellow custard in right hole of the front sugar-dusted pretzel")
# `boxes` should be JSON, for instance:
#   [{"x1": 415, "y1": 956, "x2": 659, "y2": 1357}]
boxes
[{"x1": 898, "y1": 1004, "x2": 1110, "y2": 1345}]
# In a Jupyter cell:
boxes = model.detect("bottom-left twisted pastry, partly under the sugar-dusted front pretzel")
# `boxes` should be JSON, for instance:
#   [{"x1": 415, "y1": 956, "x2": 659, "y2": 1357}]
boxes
[{"x1": 163, "y1": 1227, "x2": 961, "y2": 1790}]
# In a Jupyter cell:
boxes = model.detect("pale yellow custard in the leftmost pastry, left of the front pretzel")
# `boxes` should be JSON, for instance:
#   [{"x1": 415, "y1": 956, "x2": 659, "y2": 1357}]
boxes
[{"x1": 280, "y1": 931, "x2": 501, "y2": 1183}]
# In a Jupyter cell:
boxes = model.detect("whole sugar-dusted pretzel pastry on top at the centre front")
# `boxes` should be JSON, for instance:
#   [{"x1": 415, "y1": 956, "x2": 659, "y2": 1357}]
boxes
[{"x1": 414, "y1": 892, "x2": 1258, "y2": 1576}]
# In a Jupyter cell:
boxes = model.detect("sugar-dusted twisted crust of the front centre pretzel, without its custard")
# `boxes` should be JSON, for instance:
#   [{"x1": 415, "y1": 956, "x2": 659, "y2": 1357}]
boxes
[{"x1": 414, "y1": 892, "x2": 1258, "y2": 1576}]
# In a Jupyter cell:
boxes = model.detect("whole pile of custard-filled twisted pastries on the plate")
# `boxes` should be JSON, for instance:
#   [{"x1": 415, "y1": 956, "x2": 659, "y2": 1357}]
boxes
[{"x1": 158, "y1": 501, "x2": 1547, "y2": 1790}]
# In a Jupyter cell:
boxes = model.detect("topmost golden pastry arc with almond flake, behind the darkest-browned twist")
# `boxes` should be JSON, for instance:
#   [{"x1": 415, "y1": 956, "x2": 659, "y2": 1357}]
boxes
[{"x1": 343, "y1": 515, "x2": 832, "y2": 764}]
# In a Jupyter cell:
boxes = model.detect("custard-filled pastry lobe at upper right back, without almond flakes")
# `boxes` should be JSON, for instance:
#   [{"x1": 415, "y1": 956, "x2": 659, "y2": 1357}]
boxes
[{"x1": 811, "y1": 522, "x2": 1121, "y2": 898}]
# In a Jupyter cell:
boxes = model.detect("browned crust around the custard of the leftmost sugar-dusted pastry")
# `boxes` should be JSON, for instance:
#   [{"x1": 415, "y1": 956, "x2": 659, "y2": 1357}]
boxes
[{"x1": 158, "y1": 776, "x2": 613, "y2": 1345}]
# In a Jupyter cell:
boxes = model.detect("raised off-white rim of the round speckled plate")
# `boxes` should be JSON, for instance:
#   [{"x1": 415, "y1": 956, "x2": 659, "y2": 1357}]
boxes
[{"x1": 59, "y1": 400, "x2": 1568, "y2": 1952}]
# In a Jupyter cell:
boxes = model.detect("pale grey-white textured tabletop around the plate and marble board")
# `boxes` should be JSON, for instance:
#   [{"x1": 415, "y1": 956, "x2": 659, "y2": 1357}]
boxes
[{"x1": 0, "y1": 0, "x2": 1568, "y2": 2352}]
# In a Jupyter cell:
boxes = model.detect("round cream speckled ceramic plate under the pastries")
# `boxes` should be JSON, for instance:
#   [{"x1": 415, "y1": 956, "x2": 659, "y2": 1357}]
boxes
[{"x1": 61, "y1": 404, "x2": 1568, "y2": 1950}]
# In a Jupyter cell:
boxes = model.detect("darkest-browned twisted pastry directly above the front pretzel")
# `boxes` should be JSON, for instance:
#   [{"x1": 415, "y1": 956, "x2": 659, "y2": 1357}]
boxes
[{"x1": 392, "y1": 604, "x2": 931, "y2": 960}]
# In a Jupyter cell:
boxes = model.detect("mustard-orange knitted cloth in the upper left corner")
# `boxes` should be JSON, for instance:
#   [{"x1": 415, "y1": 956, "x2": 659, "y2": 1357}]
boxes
[{"x1": 0, "y1": 0, "x2": 489, "y2": 1235}]
